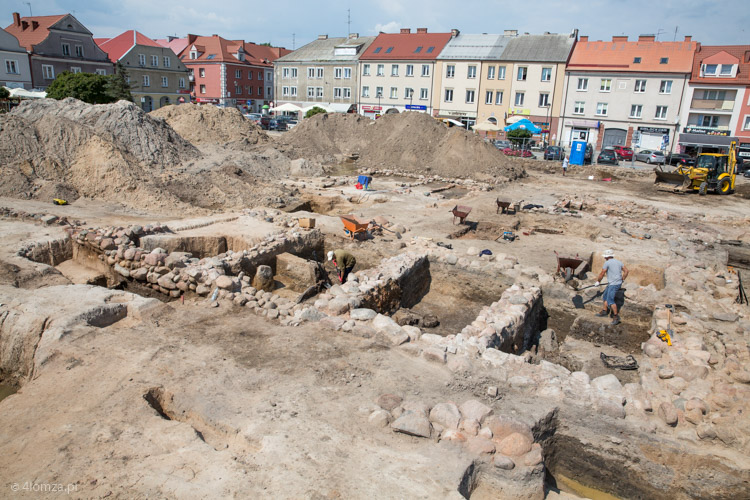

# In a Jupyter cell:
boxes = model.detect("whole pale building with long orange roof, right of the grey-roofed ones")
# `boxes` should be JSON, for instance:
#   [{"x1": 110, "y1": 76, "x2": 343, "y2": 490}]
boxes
[{"x1": 558, "y1": 35, "x2": 697, "y2": 151}]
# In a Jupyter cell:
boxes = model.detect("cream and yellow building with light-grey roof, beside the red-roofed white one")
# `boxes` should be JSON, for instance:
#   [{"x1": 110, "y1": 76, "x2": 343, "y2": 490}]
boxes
[{"x1": 432, "y1": 32, "x2": 510, "y2": 127}]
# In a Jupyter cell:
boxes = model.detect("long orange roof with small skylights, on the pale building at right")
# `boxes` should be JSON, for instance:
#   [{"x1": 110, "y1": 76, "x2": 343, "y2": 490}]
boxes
[{"x1": 567, "y1": 35, "x2": 698, "y2": 73}]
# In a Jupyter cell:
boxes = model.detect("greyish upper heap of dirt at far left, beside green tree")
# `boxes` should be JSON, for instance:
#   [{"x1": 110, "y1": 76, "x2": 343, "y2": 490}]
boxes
[{"x1": 10, "y1": 98, "x2": 200, "y2": 168}]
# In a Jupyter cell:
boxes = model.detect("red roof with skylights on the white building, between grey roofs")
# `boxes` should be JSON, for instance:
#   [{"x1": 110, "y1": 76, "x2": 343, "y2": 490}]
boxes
[{"x1": 360, "y1": 33, "x2": 451, "y2": 61}]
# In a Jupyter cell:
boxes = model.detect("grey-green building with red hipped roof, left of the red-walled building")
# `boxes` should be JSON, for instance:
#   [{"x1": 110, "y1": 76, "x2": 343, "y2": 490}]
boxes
[{"x1": 96, "y1": 30, "x2": 190, "y2": 112}]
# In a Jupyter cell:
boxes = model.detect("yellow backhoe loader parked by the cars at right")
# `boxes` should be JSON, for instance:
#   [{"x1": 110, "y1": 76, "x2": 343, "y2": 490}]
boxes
[{"x1": 654, "y1": 141, "x2": 737, "y2": 195}]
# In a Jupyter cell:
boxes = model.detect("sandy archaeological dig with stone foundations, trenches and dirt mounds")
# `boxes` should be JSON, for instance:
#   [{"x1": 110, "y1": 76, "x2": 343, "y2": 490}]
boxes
[{"x1": 0, "y1": 98, "x2": 750, "y2": 499}]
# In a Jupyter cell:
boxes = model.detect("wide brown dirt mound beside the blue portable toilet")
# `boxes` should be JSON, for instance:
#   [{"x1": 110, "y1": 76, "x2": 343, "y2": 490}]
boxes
[{"x1": 281, "y1": 112, "x2": 524, "y2": 179}]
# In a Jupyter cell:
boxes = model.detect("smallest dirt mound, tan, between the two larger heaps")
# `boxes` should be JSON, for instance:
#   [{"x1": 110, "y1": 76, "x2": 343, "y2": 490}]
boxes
[{"x1": 150, "y1": 104, "x2": 269, "y2": 149}]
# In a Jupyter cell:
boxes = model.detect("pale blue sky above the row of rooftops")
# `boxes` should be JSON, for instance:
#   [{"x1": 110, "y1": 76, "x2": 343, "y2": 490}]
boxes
[{"x1": 0, "y1": 0, "x2": 750, "y2": 49}]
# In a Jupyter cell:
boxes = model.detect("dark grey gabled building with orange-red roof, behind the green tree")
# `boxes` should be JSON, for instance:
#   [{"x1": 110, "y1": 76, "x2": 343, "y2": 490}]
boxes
[{"x1": 5, "y1": 12, "x2": 114, "y2": 89}]
